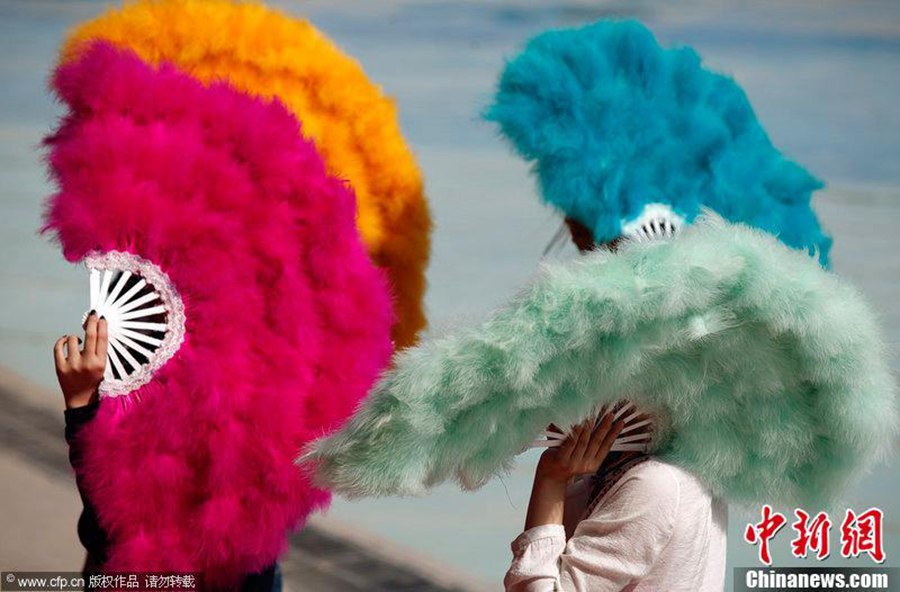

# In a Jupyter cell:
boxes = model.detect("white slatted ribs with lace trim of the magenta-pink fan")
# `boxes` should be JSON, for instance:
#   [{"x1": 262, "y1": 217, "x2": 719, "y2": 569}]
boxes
[{"x1": 84, "y1": 251, "x2": 185, "y2": 397}]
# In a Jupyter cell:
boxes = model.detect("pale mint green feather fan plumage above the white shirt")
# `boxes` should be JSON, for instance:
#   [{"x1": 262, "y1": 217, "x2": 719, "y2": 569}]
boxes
[{"x1": 300, "y1": 215, "x2": 896, "y2": 507}]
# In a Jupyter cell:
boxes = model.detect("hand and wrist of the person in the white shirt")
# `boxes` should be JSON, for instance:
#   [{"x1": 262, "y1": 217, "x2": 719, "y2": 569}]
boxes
[{"x1": 525, "y1": 413, "x2": 624, "y2": 530}]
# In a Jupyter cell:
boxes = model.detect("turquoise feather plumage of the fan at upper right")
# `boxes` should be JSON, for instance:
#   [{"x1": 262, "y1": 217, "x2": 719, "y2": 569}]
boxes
[{"x1": 485, "y1": 20, "x2": 831, "y2": 266}]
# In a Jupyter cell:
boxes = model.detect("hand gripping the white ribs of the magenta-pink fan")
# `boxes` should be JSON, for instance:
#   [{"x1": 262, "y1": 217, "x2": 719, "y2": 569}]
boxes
[{"x1": 53, "y1": 311, "x2": 109, "y2": 409}]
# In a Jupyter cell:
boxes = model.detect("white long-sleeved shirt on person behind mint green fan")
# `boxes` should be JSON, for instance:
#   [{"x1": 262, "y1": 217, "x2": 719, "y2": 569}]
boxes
[{"x1": 504, "y1": 458, "x2": 728, "y2": 592}]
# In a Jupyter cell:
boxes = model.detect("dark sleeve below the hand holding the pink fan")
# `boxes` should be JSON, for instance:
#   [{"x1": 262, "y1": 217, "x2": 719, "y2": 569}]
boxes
[{"x1": 65, "y1": 401, "x2": 109, "y2": 571}]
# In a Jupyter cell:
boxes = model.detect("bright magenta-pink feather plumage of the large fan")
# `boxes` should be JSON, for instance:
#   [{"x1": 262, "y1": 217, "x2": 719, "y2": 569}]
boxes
[{"x1": 44, "y1": 43, "x2": 392, "y2": 587}]
